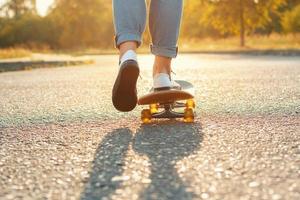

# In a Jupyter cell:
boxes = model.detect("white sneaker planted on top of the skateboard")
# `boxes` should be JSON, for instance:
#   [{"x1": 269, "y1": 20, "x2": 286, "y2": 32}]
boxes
[{"x1": 153, "y1": 73, "x2": 180, "y2": 91}]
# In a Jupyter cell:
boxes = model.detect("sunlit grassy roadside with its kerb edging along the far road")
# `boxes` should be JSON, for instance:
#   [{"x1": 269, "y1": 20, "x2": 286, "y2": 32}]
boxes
[{"x1": 0, "y1": 34, "x2": 300, "y2": 73}]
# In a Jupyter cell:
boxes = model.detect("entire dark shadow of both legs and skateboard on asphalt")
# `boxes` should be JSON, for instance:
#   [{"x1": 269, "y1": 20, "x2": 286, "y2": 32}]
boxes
[{"x1": 81, "y1": 122, "x2": 202, "y2": 199}]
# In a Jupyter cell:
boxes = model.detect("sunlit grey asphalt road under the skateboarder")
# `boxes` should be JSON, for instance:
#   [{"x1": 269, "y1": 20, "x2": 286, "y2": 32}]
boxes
[{"x1": 0, "y1": 54, "x2": 300, "y2": 200}]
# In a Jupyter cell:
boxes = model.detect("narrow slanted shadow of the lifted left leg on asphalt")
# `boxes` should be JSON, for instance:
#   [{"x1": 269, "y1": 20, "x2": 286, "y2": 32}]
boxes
[{"x1": 81, "y1": 128, "x2": 132, "y2": 200}]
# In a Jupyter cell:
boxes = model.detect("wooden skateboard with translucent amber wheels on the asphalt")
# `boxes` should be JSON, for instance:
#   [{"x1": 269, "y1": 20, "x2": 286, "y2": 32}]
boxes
[{"x1": 138, "y1": 80, "x2": 196, "y2": 124}]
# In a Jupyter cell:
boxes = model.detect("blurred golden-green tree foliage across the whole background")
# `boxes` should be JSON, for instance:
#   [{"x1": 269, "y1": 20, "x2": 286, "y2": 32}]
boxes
[{"x1": 0, "y1": 0, "x2": 300, "y2": 49}]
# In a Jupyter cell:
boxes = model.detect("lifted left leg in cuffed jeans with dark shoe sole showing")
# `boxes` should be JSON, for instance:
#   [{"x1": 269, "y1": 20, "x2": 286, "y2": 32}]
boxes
[{"x1": 112, "y1": 0, "x2": 146, "y2": 112}]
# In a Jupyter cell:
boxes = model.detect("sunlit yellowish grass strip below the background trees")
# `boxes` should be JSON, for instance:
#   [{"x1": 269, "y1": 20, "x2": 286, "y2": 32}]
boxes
[{"x1": 0, "y1": 34, "x2": 300, "y2": 59}]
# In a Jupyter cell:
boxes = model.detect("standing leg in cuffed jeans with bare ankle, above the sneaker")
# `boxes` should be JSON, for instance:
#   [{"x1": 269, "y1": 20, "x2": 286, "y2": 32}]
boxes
[{"x1": 149, "y1": 0, "x2": 183, "y2": 76}]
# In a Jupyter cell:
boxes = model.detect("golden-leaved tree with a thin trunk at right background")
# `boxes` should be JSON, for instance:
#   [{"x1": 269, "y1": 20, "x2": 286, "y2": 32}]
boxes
[{"x1": 200, "y1": 0, "x2": 286, "y2": 46}]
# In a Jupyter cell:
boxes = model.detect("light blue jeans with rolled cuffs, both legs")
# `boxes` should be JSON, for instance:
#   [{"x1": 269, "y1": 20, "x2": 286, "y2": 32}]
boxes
[{"x1": 113, "y1": 0, "x2": 183, "y2": 58}]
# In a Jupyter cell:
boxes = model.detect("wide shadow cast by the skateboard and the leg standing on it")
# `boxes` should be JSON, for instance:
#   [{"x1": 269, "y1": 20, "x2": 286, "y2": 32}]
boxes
[{"x1": 133, "y1": 122, "x2": 202, "y2": 199}]
